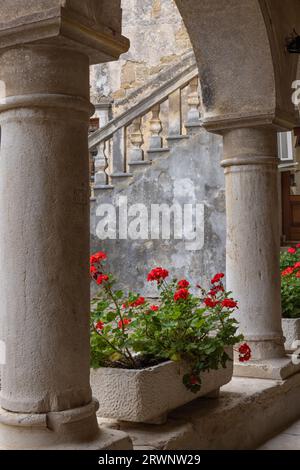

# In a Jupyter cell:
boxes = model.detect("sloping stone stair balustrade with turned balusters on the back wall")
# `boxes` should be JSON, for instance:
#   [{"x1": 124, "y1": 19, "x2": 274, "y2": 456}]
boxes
[{"x1": 89, "y1": 57, "x2": 201, "y2": 201}]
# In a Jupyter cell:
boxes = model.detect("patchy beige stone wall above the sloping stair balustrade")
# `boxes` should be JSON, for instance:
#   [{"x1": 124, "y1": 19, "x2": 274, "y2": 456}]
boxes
[{"x1": 91, "y1": 0, "x2": 191, "y2": 112}]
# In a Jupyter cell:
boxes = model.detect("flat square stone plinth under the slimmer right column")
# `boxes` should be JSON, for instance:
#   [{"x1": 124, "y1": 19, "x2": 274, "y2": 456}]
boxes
[{"x1": 233, "y1": 356, "x2": 300, "y2": 380}]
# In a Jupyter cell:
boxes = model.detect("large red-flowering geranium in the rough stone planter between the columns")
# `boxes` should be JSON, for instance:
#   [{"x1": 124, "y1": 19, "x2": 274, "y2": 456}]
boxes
[{"x1": 90, "y1": 252, "x2": 251, "y2": 393}]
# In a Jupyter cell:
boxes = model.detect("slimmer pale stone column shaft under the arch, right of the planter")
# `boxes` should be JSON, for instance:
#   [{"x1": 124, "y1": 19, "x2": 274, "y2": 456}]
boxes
[{"x1": 222, "y1": 128, "x2": 285, "y2": 361}]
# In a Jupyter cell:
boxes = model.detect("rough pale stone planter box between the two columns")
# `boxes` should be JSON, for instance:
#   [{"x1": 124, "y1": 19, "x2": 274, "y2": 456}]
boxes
[{"x1": 91, "y1": 350, "x2": 233, "y2": 424}]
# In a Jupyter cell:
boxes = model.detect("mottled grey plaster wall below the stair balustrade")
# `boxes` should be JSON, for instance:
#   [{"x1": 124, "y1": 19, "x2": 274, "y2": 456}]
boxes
[{"x1": 92, "y1": 130, "x2": 225, "y2": 296}]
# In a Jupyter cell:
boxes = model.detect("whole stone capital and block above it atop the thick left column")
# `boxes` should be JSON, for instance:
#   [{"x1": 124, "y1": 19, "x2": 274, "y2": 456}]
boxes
[{"x1": 0, "y1": 0, "x2": 129, "y2": 64}]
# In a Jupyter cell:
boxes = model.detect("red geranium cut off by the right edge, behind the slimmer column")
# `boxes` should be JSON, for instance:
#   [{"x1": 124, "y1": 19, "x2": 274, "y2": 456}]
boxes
[{"x1": 280, "y1": 244, "x2": 300, "y2": 318}]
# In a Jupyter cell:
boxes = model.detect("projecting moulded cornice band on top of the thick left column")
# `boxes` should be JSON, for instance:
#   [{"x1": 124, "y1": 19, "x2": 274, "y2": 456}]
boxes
[{"x1": 0, "y1": 8, "x2": 129, "y2": 64}]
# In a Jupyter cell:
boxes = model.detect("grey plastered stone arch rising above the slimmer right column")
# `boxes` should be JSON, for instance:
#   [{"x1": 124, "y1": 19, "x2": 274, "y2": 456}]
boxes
[{"x1": 176, "y1": 0, "x2": 300, "y2": 130}]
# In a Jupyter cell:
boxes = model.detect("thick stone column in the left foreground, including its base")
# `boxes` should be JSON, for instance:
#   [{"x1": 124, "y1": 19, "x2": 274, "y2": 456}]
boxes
[{"x1": 0, "y1": 2, "x2": 128, "y2": 449}]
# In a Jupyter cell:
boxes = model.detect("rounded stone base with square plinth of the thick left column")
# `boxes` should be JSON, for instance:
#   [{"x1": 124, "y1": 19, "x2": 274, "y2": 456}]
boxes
[{"x1": 0, "y1": 401, "x2": 132, "y2": 450}]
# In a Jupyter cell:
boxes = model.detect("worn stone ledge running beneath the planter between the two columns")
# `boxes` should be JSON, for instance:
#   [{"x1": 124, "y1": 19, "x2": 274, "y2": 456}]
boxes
[{"x1": 99, "y1": 373, "x2": 300, "y2": 450}]
